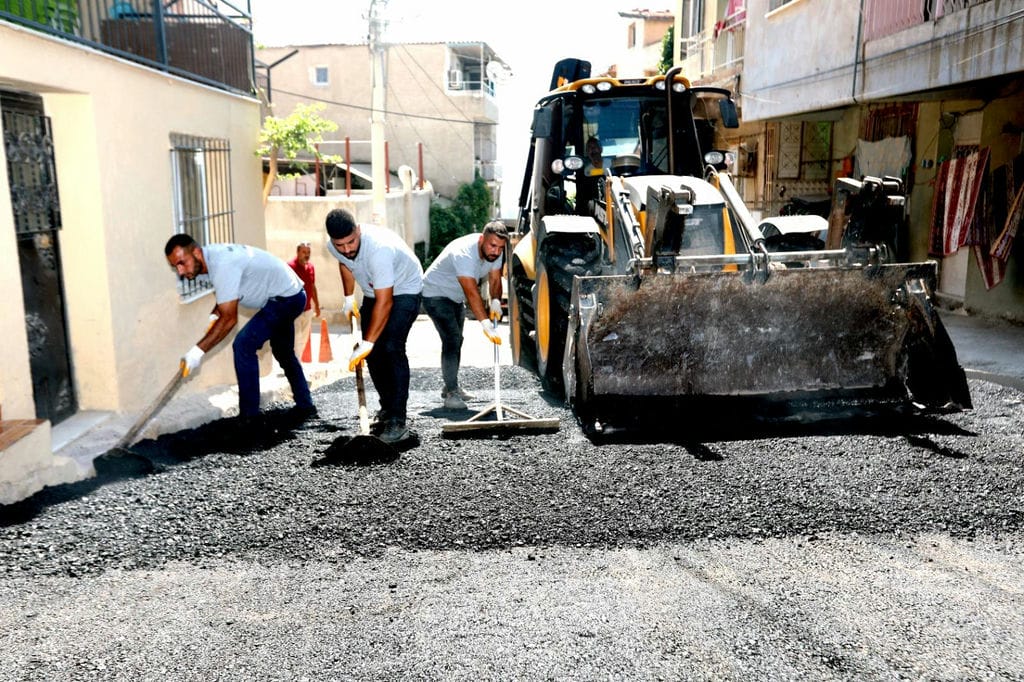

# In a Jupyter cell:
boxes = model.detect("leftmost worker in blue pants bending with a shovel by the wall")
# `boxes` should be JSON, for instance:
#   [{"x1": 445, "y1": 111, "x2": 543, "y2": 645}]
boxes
[{"x1": 164, "y1": 235, "x2": 316, "y2": 428}]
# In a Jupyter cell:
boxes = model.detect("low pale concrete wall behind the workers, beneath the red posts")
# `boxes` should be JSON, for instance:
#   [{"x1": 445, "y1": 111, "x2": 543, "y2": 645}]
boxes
[{"x1": 265, "y1": 188, "x2": 432, "y2": 313}]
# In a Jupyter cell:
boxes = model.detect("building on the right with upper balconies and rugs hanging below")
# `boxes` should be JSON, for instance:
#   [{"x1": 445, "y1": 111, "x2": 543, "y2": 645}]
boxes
[{"x1": 677, "y1": 0, "x2": 1024, "y2": 321}]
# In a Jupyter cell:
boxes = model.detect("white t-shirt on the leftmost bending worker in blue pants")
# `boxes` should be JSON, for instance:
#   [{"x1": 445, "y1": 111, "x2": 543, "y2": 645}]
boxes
[{"x1": 203, "y1": 244, "x2": 302, "y2": 309}]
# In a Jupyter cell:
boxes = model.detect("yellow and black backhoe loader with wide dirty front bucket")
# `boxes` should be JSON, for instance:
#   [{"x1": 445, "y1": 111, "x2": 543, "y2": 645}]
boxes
[{"x1": 507, "y1": 59, "x2": 971, "y2": 428}]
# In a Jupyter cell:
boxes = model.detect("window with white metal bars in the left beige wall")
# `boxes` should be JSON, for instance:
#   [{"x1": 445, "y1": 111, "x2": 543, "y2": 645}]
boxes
[{"x1": 171, "y1": 133, "x2": 234, "y2": 300}]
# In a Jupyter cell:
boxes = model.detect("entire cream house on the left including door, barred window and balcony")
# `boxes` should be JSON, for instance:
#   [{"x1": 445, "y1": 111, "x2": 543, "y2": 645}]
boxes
[{"x1": 0, "y1": 0, "x2": 264, "y2": 503}]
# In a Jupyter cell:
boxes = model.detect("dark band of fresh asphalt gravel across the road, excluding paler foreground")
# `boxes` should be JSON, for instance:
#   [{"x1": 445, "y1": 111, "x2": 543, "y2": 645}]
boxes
[{"x1": 0, "y1": 368, "x2": 1024, "y2": 576}]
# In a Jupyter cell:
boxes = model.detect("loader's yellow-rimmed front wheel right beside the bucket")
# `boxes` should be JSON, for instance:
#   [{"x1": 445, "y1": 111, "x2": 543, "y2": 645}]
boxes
[{"x1": 534, "y1": 235, "x2": 601, "y2": 398}]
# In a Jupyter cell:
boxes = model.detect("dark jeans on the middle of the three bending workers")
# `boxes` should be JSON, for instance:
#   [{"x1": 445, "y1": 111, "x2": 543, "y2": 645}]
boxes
[{"x1": 359, "y1": 294, "x2": 420, "y2": 422}]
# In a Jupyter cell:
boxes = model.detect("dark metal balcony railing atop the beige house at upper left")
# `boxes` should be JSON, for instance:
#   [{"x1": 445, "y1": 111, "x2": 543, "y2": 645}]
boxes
[{"x1": 0, "y1": 0, "x2": 254, "y2": 94}]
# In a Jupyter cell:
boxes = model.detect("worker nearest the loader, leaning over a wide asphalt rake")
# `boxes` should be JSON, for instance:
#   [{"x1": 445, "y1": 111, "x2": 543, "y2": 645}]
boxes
[{"x1": 423, "y1": 220, "x2": 509, "y2": 410}]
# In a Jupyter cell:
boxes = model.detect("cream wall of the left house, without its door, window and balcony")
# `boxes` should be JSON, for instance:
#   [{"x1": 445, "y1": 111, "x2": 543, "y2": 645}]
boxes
[{"x1": 0, "y1": 23, "x2": 264, "y2": 418}]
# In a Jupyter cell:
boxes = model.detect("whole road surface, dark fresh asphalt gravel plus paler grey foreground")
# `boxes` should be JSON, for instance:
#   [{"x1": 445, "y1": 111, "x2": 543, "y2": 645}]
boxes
[{"x1": 0, "y1": 368, "x2": 1024, "y2": 680}]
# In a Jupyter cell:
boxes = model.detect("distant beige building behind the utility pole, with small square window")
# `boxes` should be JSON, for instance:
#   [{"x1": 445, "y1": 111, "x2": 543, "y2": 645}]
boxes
[{"x1": 256, "y1": 42, "x2": 503, "y2": 198}]
